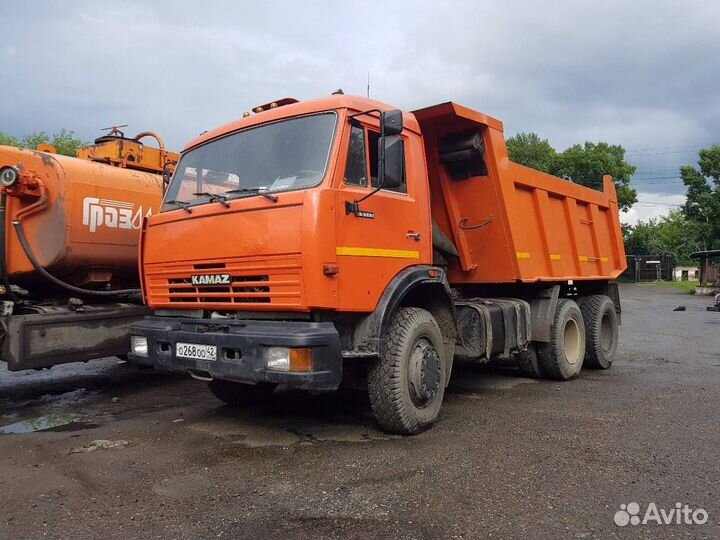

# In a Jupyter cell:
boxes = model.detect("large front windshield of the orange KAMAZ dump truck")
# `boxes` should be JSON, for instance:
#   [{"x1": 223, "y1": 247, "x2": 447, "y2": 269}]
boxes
[{"x1": 162, "y1": 112, "x2": 337, "y2": 211}]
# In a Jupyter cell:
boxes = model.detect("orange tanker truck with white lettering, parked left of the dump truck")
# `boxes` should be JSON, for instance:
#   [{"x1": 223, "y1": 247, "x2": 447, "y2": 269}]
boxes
[{"x1": 0, "y1": 128, "x2": 178, "y2": 371}]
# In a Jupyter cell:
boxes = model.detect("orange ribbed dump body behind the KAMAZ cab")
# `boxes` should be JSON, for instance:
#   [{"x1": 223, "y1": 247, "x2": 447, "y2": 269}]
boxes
[{"x1": 414, "y1": 103, "x2": 626, "y2": 284}]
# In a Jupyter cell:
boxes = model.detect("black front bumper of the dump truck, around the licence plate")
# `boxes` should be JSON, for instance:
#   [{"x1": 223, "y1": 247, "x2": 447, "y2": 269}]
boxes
[{"x1": 128, "y1": 317, "x2": 342, "y2": 390}]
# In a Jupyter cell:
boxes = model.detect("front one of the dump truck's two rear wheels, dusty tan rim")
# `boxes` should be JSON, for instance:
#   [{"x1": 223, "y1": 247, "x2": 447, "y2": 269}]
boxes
[{"x1": 538, "y1": 298, "x2": 585, "y2": 381}]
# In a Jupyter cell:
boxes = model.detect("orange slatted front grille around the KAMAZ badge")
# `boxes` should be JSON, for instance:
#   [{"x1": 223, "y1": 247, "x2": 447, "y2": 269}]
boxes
[{"x1": 146, "y1": 256, "x2": 302, "y2": 309}]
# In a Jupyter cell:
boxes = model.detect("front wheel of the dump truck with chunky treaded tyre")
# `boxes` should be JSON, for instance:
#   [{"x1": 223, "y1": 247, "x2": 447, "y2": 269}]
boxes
[{"x1": 368, "y1": 307, "x2": 447, "y2": 435}]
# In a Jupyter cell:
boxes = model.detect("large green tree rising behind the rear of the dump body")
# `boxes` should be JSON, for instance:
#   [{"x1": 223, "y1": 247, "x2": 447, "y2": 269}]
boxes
[{"x1": 550, "y1": 142, "x2": 637, "y2": 212}]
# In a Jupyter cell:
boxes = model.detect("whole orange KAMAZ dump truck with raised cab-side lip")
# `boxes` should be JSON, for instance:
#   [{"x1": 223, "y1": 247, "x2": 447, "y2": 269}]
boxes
[{"x1": 129, "y1": 95, "x2": 625, "y2": 434}]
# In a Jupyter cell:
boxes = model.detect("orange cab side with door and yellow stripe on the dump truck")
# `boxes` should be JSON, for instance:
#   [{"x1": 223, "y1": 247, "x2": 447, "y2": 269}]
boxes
[{"x1": 335, "y1": 121, "x2": 432, "y2": 312}]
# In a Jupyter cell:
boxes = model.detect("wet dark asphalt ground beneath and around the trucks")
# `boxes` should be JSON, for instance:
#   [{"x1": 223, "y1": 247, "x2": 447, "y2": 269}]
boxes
[{"x1": 0, "y1": 285, "x2": 720, "y2": 539}]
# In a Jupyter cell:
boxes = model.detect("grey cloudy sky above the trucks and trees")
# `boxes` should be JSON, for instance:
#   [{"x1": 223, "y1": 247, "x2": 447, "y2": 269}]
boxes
[{"x1": 0, "y1": 0, "x2": 720, "y2": 221}]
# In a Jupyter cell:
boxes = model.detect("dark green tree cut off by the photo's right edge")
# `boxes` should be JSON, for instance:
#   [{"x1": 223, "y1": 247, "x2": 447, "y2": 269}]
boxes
[{"x1": 680, "y1": 144, "x2": 720, "y2": 249}]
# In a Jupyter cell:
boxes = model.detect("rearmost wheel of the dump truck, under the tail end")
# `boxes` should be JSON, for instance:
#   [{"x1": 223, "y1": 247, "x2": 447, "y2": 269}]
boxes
[{"x1": 580, "y1": 294, "x2": 619, "y2": 369}]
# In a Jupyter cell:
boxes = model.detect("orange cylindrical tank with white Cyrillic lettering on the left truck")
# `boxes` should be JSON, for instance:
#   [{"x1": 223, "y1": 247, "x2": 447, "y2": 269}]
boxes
[{"x1": 0, "y1": 142, "x2": 163, "y2": 289}]
